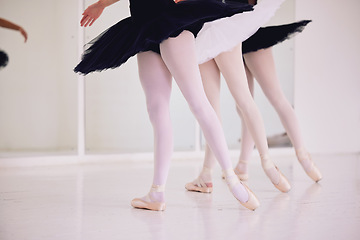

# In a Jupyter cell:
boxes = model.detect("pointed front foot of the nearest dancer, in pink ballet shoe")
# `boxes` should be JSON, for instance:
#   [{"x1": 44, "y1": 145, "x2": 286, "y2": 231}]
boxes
[{"x1": 224, "y1": 169, "x2": 260, "y2": 210}]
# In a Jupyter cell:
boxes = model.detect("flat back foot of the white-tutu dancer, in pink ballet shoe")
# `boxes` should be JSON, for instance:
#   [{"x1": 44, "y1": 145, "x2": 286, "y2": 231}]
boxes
[{"x1": 185, "y1": 167, "x2": 213, "y2": 193}]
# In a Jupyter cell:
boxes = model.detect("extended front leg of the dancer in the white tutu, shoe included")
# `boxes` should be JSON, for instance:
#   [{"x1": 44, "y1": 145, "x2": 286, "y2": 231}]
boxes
[{"x1": 215, "y1": 45, "x2": 291, "y2": 192}]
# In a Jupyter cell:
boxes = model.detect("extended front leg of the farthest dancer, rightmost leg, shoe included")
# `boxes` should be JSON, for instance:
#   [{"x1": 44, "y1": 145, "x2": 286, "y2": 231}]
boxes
[{"x1": 244, "y1": 48, "x2": 322, "y2": 182}]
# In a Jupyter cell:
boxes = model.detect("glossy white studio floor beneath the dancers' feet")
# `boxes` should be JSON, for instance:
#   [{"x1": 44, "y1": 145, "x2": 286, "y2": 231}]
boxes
[{"x1": 0, "y1": 154, "x2": 360, "y2": 240}]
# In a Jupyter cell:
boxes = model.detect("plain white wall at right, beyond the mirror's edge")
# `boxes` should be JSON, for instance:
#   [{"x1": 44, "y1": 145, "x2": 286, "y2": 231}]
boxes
[{"x1": 295, "y1": 0, "x2": 360, "y2": 152}]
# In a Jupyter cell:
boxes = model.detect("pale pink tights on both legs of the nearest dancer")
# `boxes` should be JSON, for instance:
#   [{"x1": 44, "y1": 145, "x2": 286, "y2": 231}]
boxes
[{"x1": 138, "y1": 31, "x2": 248, "y2": 202}]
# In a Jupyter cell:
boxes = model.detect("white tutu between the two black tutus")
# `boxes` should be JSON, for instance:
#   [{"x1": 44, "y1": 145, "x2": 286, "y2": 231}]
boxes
[{"x1": 195, "y1": 0, "x2": 284, "y2": 64}]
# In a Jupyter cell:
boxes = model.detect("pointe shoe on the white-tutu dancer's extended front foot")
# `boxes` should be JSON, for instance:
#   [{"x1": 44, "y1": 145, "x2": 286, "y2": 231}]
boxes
[{"x1": 260, "y1": 155, "x2": 291, "y2": 193}]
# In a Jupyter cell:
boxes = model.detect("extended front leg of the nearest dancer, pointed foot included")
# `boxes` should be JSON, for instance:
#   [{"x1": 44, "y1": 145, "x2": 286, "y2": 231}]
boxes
[{"x1": 160, "y1": 31, "x2": 259, "y2": 210}]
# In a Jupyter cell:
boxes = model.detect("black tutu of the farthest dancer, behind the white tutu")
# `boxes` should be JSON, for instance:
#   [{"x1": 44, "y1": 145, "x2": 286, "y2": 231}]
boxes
[{"x1": 242, "y1": 20, "x2": 311, "y2": 54}]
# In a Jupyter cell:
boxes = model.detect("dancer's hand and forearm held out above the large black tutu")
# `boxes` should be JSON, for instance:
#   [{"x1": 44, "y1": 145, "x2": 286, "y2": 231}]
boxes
[{"x1": 80, "y1": 0, "x2": 120, "y2": 27}]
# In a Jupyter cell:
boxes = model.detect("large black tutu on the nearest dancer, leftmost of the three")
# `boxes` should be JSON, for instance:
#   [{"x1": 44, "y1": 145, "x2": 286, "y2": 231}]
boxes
[{"x1": 74, "y1": 0, "x2": 253, "y2": 74}]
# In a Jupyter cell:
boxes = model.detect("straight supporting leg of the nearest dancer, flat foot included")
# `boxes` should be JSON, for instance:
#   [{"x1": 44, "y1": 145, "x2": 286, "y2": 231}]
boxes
[{"x1": 131, "y1": 51, "x2": 173, "y2": 210}]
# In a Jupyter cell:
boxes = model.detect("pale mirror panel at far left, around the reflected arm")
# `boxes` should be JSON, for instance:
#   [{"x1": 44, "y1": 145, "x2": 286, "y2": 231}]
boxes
[{"x1": 0, "y1": 0, "x2": 78, "y2": 152}]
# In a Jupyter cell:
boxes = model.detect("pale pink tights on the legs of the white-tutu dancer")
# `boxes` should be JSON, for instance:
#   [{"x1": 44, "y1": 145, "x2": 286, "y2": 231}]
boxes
[{"x1": 200, "y1": 45, "x2": 279, "y2": 185}]
